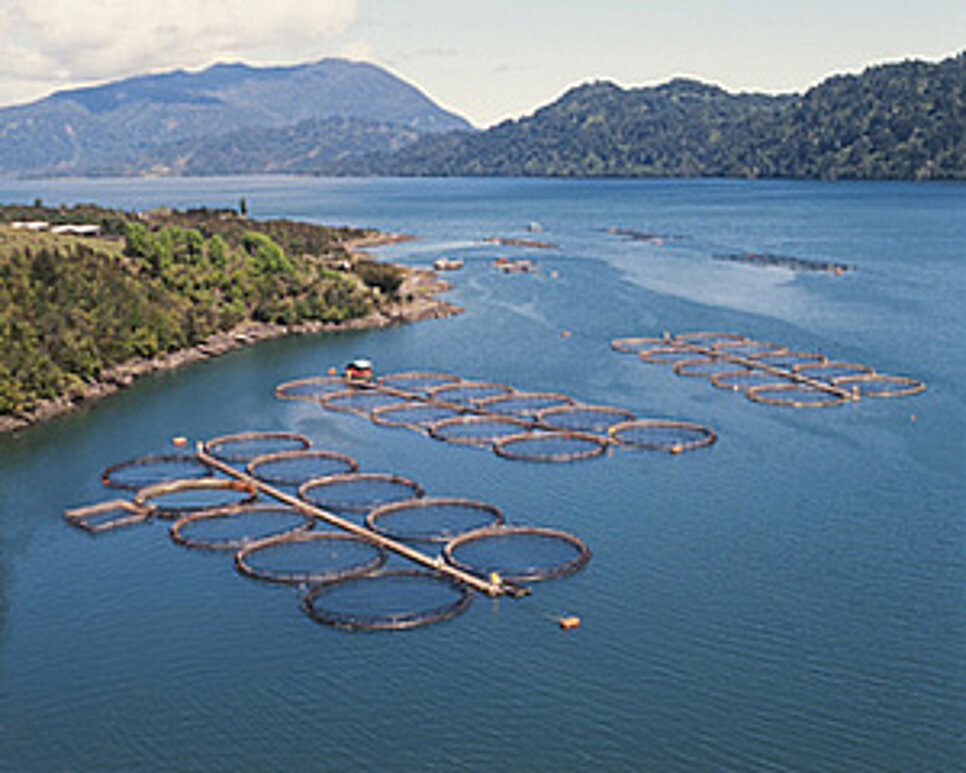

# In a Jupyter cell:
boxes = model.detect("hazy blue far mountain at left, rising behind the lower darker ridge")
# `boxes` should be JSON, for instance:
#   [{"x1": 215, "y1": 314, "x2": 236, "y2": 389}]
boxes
[{"x1": 0, "y1": 59, "x2": 470, "y2": 175}]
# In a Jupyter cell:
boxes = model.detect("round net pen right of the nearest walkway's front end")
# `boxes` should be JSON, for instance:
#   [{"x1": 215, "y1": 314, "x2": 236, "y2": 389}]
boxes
[{"x1": 443, "y1": 526, "x2": 590, "y2": 582}]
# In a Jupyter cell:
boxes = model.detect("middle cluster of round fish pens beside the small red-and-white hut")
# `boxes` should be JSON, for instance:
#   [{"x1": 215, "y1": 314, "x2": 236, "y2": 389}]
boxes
[{"x1": 275, "y1": 371, "x2": 717, "y2": 462}]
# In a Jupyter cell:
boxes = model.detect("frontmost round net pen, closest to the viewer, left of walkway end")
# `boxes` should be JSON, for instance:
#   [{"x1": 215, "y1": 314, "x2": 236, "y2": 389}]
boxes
[{"x1": 302, "y1": 570, "x2": 472, "y2": 631}]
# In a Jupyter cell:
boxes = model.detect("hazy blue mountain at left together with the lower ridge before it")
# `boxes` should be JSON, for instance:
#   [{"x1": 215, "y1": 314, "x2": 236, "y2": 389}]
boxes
[{"x1": 0, "y1": 59, "x2": 471, "y2": 175}]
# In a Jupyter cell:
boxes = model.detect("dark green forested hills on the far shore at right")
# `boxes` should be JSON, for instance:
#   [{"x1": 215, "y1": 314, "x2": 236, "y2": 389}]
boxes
[{"x1": 328, "y1": 53, "x2": 966, "y2": 179}]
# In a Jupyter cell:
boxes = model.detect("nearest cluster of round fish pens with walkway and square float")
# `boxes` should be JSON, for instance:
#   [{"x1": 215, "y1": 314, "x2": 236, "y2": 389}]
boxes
[{"x1": 64, "y1": 432, "x2": 590, "y2": 630}]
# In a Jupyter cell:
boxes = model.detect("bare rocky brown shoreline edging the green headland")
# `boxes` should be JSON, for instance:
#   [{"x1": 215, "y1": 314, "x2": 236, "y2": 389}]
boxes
[{"x1": 0, "y1": 233, "x2": 463, "y2": 436}]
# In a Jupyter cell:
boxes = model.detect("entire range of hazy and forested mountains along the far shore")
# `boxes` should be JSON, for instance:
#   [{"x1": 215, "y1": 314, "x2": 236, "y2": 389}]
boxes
[{"x1": 0, "y1": 53, "x2": 966, "y2": 179}]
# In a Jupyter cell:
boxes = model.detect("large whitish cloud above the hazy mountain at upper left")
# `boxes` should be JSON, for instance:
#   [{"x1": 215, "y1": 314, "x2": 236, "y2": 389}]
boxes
[{"x1": 0, "y1": 0, "x2": 357, "y2": 81}]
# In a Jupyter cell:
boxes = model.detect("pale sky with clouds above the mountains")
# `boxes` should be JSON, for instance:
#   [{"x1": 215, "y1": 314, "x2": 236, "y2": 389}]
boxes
[{"x1": 0, "y1": 0, "x2": 966, "y2": 127}]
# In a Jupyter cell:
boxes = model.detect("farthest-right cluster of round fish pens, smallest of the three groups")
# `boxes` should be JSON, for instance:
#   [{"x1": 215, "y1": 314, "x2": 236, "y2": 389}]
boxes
[{"x1": 611, "y1": 331, "x2": 926, "y2": 408}]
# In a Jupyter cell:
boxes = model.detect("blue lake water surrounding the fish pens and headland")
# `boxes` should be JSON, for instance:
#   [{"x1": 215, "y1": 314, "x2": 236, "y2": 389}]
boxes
[{"x1": 0, "y1": 178, "x2": 966, "y2": 771}]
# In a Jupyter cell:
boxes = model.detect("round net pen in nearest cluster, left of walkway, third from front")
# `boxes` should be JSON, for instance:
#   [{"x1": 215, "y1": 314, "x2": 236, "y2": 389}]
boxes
[{"x1": 170, "y1": 505, "x2": 315, "y2": 550}]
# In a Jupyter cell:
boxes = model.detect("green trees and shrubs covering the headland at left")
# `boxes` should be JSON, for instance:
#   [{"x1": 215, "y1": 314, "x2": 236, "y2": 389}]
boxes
[{"x1": 0, "y1": 201, "x2": 402, "y2": 415}]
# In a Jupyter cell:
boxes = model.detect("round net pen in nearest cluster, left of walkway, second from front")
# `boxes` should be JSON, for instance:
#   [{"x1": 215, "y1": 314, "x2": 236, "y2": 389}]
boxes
[{"x1": 235, "y1": 531, "x2": 386, "y2": 584}]
